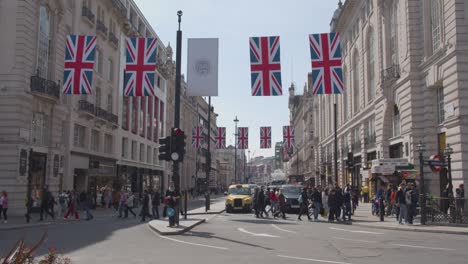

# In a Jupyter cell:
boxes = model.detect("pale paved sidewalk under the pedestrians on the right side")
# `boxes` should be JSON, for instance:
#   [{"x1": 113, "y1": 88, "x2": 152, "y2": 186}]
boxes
[{"x1": 353, "y1": 203, "x2": 468, "y2": 235}]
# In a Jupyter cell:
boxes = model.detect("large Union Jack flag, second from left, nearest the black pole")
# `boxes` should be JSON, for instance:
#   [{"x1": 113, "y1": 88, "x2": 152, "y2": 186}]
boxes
[{"x1": 124, "y1": 38, "x2": 157, "y2": 96}]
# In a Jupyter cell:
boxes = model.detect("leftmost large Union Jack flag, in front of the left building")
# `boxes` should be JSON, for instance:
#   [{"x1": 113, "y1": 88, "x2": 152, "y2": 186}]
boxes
[{"x1": 63, "y1": 35, "x2": 96, "y2": 94}]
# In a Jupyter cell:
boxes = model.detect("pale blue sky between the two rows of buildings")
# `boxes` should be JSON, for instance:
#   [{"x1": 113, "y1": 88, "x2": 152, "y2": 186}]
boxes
[{"x1": 134, "y1": 0, "x2": 338, "y2": 157}]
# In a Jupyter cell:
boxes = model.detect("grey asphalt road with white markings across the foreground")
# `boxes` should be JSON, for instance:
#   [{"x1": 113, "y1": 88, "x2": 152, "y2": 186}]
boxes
[{"x1": 0, "y1": 206, "x2": 468, "y2": 264}]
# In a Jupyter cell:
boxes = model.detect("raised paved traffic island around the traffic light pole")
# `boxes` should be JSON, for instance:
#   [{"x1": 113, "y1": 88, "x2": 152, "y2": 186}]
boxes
[{"x1": 148, "y1": 197, "x2": 225, "y2": 236}]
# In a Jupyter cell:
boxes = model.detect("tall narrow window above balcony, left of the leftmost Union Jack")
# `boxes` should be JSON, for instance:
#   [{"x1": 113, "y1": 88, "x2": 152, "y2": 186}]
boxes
[{"x1": 37, "y1": 6, "x2": 51, "y2": 79}]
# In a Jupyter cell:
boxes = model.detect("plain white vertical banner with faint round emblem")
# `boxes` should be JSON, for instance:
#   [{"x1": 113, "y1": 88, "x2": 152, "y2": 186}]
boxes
[{"x1": 187, "y1": 38, "x2": 218, "y2": 96}]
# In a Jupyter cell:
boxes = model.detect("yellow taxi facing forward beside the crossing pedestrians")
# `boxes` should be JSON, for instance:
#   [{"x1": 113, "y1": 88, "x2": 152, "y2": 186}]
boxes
[{"x1": 226, "y1": 184, "x2": 253, "y2": 213}]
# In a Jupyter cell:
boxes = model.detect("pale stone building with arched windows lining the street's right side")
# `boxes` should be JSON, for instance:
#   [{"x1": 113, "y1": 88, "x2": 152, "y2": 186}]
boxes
[{"x1": 313, "y1": 0, "x2": 468, "y2": 195}]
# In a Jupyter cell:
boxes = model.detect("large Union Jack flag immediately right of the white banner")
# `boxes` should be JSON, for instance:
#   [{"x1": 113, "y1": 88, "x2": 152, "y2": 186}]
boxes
[{"x1": 250, "y1": 36, "x2": 283, "y2": 96}]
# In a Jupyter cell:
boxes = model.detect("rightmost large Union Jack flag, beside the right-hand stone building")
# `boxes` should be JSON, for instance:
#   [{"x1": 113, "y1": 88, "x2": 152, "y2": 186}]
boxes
[{"x1": 309, "y1": 33, "x2": 344, "y2": 94}]
